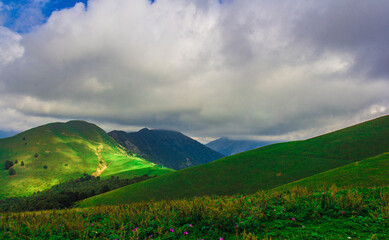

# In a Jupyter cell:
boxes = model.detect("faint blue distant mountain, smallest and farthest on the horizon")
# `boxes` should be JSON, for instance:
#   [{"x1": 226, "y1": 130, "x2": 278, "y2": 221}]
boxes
[{"x1": 205, "y1": 137, "x2": 274, "y2": 156}]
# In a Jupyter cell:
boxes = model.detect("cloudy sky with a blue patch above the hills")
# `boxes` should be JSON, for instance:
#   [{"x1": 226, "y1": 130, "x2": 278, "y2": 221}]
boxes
[{"x1": 0, "y1": 0, "x2": 389, "y2": 141}]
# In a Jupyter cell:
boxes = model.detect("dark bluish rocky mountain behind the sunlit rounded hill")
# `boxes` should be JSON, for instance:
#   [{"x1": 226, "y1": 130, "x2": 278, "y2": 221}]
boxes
[{"x1": 109, "y1": 128, "x2": 224, "y2": 170}]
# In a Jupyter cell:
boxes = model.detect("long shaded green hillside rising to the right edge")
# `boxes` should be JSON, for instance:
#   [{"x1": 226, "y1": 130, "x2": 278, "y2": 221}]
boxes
[{"x1": 80, "y1": 116, "x2": 389, "y2": 206}]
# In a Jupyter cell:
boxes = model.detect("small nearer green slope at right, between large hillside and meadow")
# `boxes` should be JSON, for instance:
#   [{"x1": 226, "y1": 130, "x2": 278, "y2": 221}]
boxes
[{"x1": 274, "y1": 153, "x2": 389, "y2": 191}]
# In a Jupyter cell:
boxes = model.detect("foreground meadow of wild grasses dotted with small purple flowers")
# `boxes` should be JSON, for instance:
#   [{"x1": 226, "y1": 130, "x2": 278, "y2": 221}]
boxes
[{"x1": 0, "y1": 186, "x2": 389, "y2": 240}]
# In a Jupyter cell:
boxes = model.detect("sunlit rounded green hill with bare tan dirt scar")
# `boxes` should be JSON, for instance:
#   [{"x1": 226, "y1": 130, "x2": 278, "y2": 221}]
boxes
[{"x1": 0, "y1": 121, "x2": 171, "y2": 198}]
